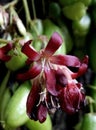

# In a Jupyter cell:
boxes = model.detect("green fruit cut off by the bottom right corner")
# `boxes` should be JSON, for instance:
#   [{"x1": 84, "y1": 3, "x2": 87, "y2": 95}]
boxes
[{"x1": 80, "y1": 113, "x2": 96, "y2": 130}]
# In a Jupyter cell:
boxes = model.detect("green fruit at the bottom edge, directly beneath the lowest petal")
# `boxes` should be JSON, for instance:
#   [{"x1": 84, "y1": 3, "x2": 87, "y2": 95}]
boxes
[{"x1": 25, "y1": 115, "x2": 52, "y2": 130}]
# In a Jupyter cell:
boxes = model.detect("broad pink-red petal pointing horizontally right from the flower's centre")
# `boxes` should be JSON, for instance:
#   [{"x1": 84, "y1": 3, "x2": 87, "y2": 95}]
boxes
[{"x1": 50, "y1": 55, "x2": 80, "y2": 67}]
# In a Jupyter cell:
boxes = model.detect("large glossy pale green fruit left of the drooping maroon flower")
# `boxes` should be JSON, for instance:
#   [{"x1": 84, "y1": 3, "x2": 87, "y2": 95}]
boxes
[{"x1": 5, "y1": 82, "x2": 30, "y2": 127}]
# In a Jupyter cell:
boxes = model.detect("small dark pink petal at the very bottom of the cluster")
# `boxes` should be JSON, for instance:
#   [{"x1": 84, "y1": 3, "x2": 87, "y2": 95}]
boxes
[{"x1": 37, "y1": 104, "x2": 47, "y2": 123}]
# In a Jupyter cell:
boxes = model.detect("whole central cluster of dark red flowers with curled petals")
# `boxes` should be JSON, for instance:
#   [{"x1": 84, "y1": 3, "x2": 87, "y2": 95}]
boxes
[{"x1": 17, "y1": 32, "x2": 88, "y2": 123}]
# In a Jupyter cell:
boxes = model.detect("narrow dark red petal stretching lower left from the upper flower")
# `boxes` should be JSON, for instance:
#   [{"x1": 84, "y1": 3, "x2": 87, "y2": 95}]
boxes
[{"x1": 17, "y1": 63, "x2": 42, "y2": 81}]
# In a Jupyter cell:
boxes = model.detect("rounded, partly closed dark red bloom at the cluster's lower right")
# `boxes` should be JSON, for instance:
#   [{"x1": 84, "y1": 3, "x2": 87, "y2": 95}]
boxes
[{"x1": 58, "y1": 81, "x2": 85, "y2": 114}]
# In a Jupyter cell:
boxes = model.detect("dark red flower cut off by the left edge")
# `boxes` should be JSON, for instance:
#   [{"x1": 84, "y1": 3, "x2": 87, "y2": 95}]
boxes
[{"x1": 0, "y1": 43, "x2": 12, "y2": 61}]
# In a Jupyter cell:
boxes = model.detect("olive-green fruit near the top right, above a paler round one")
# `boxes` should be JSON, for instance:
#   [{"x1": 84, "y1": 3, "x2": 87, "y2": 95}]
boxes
[{"x1": 62, "y1": 2, "x2": 86, "y2": 20}]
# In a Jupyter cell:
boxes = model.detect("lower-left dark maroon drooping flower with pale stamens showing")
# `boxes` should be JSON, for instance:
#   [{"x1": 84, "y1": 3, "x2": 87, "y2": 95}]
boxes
[{"x1": 26, "y1": 79, "x2": 59, "y2": 123}]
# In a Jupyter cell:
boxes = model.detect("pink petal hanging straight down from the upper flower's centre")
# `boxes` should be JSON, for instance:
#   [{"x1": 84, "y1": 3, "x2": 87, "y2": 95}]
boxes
[{"x1": 44, "y1": 68, "x2": 58, "y2": 96}]
